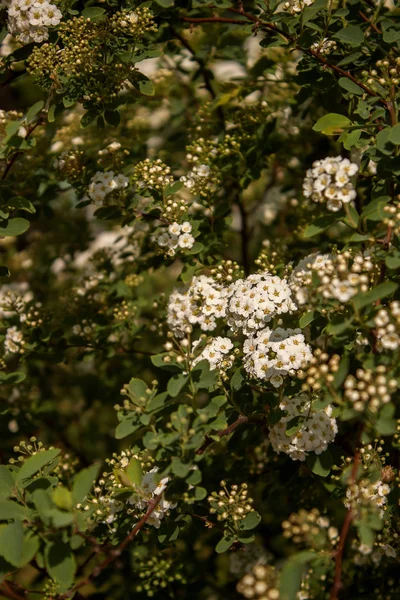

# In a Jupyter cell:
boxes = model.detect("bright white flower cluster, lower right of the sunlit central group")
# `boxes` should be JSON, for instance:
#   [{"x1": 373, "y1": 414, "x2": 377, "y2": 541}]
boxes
[{"x1": 243, "y1": 327, "x2": 312, "y2": 387}]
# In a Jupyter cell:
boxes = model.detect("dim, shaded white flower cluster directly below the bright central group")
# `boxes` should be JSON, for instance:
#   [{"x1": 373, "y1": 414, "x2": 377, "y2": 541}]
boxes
[{"x1": 269, "y1": 394, "x2": 338, "y2": 460}]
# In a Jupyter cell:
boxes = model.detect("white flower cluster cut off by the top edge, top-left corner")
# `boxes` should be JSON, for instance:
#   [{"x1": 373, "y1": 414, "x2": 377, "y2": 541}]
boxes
[{"x1": 8, "y1": 0, "x2": 62, "y2": 44}]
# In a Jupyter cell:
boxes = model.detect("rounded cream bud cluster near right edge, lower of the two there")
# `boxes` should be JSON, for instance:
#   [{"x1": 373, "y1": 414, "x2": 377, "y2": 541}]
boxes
[{"x1": 344, "y1": 365, "x2": 397, "y2": 413}]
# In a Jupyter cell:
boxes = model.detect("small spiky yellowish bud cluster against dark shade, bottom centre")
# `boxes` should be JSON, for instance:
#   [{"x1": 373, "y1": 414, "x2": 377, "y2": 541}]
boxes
[{"x1": 208, "y1": 481, "x2": 254, "y2": 532}]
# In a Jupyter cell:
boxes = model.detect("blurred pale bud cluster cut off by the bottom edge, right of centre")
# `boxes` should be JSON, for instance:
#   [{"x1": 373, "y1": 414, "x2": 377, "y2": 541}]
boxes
[{"x1": 236, "y1": 565, "x2": 280, "y2": 600}]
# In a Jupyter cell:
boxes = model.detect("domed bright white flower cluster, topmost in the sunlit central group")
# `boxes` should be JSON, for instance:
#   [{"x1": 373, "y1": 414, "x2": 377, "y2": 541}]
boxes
[{"x1": 227, "y1": 273, "x2": 296, "y2": 335}]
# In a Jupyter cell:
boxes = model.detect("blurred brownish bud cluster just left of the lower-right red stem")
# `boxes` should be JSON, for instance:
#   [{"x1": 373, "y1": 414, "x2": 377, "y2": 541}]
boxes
[{"x1": 282, "y1": 508, "x2": 339, "y2": 550}]
